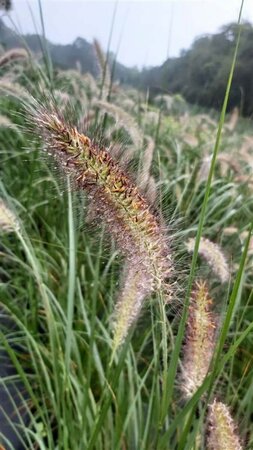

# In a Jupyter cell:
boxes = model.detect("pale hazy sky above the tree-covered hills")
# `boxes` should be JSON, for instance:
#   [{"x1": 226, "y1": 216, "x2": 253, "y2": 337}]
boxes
[{"x1": 0, "y1": 0, "x2": 253, "y2": 67}]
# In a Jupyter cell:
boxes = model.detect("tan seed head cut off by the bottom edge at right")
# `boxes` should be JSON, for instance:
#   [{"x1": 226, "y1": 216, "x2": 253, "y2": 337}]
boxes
[{"x1": 207, "y1": 399, "x2": 242, "y2": 450}]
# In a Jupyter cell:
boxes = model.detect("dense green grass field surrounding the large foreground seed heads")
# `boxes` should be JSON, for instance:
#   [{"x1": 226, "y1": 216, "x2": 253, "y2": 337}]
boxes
[{"x1": 0, "y1": 30, "x2": 253, "y2": 450}]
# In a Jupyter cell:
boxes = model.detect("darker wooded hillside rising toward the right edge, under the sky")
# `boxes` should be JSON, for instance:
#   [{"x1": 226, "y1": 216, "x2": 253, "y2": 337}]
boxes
[{"x1": 141, "y1": 22, "x2": 253, "y2": 116}]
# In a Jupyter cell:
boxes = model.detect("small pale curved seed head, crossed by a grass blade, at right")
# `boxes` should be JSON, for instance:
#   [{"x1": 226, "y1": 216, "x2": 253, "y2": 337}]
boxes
[{"x1": 186, "y1": 237, "x2": 230, "y2": 283}]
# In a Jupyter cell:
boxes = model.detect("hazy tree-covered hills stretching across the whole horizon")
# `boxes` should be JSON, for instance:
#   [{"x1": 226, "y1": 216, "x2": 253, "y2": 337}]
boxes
[{"x1": 0, "y1": 19, "x2": 253, "y2": 116}]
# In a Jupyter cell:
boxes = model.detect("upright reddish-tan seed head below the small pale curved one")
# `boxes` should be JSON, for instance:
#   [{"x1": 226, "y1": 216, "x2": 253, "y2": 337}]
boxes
[{"x1": 181, "y1": 281, "x2": 217, "y2": 398}]
